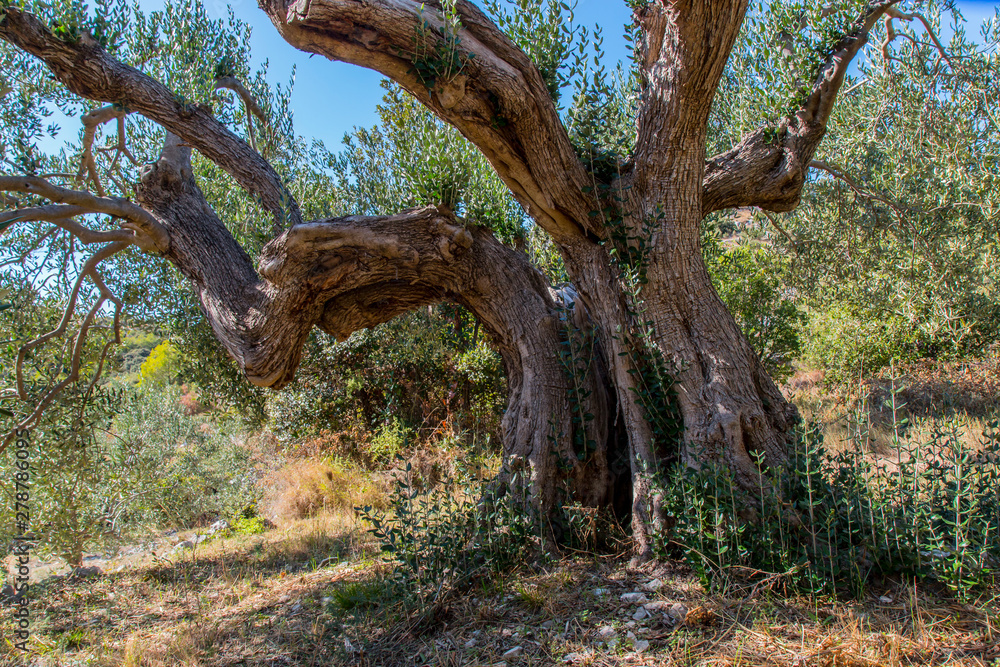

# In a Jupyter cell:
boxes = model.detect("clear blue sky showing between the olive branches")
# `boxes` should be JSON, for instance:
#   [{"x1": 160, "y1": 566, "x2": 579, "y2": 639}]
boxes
[{"x1": 201, "y1": 0, "x2": 997, "y2": 150}]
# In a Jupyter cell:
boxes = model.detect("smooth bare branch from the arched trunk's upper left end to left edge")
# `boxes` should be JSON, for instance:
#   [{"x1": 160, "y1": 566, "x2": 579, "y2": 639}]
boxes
[{"x1": 0, "y1": 176, "x2": 170, "y2": 254}]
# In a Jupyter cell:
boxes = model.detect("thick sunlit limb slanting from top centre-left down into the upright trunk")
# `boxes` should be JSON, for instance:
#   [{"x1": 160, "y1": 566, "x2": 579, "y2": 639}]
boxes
[{"x1": 260, "y1": 0, "x2": 601, "y2": 241}]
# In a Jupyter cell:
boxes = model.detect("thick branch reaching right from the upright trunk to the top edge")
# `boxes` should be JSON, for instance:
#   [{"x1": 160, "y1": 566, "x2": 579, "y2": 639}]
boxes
[{"x1": 702, "y1": 0, "x2": 898, "y2": 215}]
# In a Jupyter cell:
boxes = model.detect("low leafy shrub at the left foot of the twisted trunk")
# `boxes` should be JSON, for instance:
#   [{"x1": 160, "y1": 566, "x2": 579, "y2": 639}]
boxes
[{"x1": 358, "y1": 464, "x2": 537, "y2": 607}]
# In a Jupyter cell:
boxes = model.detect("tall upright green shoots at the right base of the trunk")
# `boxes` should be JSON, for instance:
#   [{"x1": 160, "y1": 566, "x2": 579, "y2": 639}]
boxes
[{"x1": 659, "y1": 424, "x2": 1000, "y2": 597}]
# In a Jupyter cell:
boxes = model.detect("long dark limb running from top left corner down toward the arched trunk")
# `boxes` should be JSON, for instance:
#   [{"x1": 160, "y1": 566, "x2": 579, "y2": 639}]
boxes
[{"x1": 0, "y1": 7, "x2": 301, "y2": 227}]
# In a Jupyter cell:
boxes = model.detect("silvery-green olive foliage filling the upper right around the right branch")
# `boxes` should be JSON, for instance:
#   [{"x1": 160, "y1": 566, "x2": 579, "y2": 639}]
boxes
[{"x1": 709, "y1": 2, "x2": 1000, "y2": 382}]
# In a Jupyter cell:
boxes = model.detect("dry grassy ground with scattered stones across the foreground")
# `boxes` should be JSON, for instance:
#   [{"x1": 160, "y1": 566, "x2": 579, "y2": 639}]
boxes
[{"x1": 0, "y1": 514, "x2": 1000, "y2": 667}]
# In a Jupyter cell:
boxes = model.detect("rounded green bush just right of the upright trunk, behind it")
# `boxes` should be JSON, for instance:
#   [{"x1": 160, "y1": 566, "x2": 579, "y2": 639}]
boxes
[{"x1": 702, "y1": 240, "x2": 808, "y2": 382}]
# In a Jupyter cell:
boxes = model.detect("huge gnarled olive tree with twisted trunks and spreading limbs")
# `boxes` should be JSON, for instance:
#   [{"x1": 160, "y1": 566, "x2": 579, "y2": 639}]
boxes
[{"x1": 0, "y1": 0, "x2": 984, "y2": 557}]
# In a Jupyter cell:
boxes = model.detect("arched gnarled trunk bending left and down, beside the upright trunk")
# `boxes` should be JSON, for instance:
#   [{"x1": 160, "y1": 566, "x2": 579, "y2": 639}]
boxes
[{"x1": 138, "y1": 135, "x2": 617, "y2": 536}]
